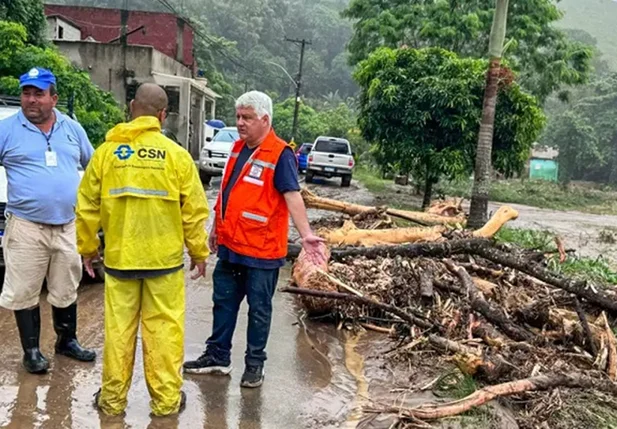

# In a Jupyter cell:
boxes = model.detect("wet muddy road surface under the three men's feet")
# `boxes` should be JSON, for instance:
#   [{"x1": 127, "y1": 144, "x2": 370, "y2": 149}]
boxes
[{"x1": 0, "y1": 178, "x2": 357, "y2": 429}]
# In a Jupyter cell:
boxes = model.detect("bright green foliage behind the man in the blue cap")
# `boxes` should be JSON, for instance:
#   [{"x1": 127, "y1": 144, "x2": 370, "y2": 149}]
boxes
[{"x1": 0, "y1": 21, "x2": 124, "y2": 146}]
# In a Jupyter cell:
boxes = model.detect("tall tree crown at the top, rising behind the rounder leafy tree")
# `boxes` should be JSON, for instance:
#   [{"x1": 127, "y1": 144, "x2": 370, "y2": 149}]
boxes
[{"x1": 344, "y1": 0, "x2": 592, "y2": 100}]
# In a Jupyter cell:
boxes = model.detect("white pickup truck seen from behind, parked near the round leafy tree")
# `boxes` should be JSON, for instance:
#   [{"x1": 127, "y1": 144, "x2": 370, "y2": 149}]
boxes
[{"x1": 306, "y1": 137, "x2": 355, "y2": 187}]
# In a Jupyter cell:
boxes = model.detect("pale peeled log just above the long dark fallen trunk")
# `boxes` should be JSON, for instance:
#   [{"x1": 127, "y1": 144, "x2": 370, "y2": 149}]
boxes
[{"x1": 320, "y1": 221, "x2": 446, "y2": 247}]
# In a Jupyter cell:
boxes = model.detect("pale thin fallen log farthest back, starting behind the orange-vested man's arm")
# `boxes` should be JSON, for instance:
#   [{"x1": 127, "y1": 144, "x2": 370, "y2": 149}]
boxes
[{"x1": 301, "y1": 188, "x2": 465, "y2": 226}]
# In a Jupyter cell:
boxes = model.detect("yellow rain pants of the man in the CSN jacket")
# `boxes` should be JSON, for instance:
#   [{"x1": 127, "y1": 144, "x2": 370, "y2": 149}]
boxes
[{"x1": 99, "y1": 270, "x2": 185, "y2": 416}]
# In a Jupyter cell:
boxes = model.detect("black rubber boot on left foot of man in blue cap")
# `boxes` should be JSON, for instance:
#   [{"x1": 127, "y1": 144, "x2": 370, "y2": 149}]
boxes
[{"x1": 15, "y1": 307, "x2": 49, "y2": 374}]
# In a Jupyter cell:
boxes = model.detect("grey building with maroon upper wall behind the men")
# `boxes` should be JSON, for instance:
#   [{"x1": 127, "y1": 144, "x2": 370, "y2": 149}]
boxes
[{"x1": 45, "y1": 5, "x2": 219, "y2": 160}]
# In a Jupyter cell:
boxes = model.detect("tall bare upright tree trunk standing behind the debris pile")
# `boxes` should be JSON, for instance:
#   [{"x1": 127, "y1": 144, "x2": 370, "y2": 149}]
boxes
[{"x1": 467, "y1": 0, "x2": 508, "y2": 229}]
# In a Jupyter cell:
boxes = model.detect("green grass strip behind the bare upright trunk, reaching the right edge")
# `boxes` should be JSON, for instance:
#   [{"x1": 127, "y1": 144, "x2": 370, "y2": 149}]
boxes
[{"x1": 437, "y1": 180, "x2": 617, "y2": 214}]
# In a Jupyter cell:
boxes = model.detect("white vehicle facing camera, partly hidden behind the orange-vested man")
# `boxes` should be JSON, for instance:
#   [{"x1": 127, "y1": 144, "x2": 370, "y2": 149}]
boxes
[{"x1": 199, "y1": 127, "x2": 240, "y2": 185}]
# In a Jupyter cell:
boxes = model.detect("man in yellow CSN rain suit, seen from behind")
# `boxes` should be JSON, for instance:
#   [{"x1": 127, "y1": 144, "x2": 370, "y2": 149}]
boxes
[{"x1": 77, "y1": 84, "x2": 208, "y2": 416}]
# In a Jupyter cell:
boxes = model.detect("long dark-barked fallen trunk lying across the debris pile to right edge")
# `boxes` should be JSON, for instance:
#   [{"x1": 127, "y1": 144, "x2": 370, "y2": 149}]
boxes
[{"x1": 332, "y1": 239, "x2": 617, "y2": 312}]
